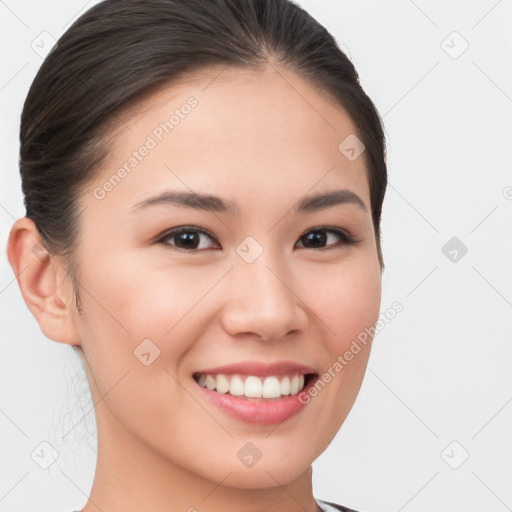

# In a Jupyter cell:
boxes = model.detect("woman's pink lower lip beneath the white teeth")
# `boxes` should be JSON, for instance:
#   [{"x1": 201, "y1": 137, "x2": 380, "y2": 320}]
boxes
[{"x1": 192, "y1": 375, "x2": 317, "y2": 425}]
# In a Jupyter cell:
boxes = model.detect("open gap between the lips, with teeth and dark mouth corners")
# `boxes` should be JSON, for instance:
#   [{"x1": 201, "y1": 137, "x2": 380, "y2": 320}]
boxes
[{"x1": 193, "y1": 372, "x2": 318, "y2": 402}]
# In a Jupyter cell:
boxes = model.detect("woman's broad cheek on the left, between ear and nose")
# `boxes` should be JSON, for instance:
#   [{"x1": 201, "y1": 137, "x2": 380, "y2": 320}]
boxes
[{"x1": 73, "y1": 257, "x2": 208, "y2": 435}]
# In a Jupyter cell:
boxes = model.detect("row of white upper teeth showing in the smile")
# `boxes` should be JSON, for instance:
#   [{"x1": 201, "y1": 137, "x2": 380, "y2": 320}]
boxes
[{"x1": 196, "y1": 373, "x2": 304, "y2": 398}]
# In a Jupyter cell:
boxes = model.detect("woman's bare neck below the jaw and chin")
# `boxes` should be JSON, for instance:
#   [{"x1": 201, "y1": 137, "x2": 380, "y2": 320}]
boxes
[{"x1": 82, "y1": 401, "x2": 318, "y2": 512}]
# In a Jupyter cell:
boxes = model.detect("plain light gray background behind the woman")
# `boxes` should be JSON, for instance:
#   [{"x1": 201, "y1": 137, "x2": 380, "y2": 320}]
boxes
[{"x1": 0, "y1": 0, "x2": 512, "y2": 512}]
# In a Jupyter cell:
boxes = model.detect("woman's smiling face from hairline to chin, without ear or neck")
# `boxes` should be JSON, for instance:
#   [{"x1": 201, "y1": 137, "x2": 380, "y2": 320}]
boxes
[{"x1": 69, "y1": 67, "x2": 381, "y2": 488}]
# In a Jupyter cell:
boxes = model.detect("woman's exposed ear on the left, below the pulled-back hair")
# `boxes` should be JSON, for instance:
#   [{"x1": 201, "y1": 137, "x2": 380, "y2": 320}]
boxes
[{"x1": 7, "y1": 217, "x2": 80, "y2": 345}]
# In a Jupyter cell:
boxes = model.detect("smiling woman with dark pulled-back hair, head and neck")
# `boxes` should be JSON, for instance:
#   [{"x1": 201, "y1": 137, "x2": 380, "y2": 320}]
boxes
[{"x1": 8, "y1": 0, "x2": 387, "y2": 512}]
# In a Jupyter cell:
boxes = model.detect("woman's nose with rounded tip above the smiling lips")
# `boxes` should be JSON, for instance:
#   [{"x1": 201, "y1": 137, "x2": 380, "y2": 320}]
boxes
[{"x1": 222, "y1": 253, "x2": 308, "y2": 342}]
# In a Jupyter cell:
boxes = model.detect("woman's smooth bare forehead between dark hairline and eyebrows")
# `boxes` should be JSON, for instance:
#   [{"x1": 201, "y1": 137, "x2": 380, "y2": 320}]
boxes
[{"x1": 82, "y1": 65, "x2": 369, "y2": 216}]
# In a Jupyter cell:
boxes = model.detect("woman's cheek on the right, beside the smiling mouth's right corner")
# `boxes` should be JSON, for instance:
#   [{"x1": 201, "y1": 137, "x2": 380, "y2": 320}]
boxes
[{"x1": 300, "y1": 255, "x2": 381, "y2": 440}]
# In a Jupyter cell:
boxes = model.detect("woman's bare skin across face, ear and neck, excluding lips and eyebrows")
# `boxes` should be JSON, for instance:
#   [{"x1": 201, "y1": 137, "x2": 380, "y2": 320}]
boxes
[{"x1": 8, "y1": 64, "x2": 381, "y2": 512}]
